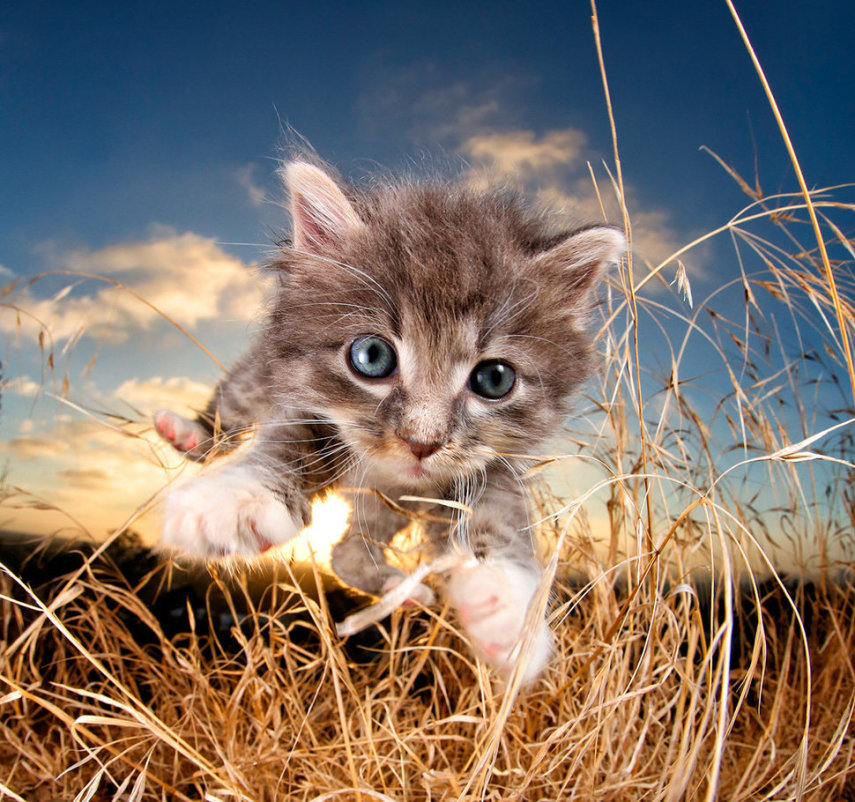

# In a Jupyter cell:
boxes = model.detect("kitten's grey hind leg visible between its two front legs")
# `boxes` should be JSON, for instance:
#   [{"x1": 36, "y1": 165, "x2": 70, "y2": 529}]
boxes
[{"x1": 332, "y1": 495, "x2": 435, "y2": 606}]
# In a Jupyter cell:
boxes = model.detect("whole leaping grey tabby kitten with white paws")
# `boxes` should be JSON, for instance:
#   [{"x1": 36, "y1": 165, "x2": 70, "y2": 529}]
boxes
[{"x1": 155, "y1": 161, "x2": 625, "y2": 680}]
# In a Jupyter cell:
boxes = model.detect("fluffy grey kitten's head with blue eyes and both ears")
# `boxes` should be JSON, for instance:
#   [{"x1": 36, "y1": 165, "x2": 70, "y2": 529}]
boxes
[{"x1": 267, "y1": 162, "x2": 625, "y2": 487}]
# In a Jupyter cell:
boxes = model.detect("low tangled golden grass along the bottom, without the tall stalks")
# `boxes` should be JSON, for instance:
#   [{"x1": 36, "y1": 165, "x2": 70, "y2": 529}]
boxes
[{"x1": 0, "y1": 536, "x2": 855, "y2": 800}]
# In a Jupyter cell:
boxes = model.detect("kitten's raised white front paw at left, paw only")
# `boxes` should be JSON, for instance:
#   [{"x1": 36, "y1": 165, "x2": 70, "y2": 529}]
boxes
[{"x1": 161, "y1": 466, "x2": 300, "y2": 558}]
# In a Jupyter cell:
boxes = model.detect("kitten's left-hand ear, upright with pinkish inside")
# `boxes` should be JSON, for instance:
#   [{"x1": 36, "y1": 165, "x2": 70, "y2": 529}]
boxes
[{"x1": 282, "y1": 162, "x2": 364, "y2": 254}]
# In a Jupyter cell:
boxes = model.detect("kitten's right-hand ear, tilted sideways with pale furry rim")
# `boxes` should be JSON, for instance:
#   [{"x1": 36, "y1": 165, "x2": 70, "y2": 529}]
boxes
[{"x1": 536, "y1": 226, "x2": 626, "y2": 303}]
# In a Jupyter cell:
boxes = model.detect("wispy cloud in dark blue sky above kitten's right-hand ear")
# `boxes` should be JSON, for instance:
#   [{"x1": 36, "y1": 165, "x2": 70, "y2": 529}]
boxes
[{"x1": 361, "y1": 67, "x2": 703, "y2": 288}]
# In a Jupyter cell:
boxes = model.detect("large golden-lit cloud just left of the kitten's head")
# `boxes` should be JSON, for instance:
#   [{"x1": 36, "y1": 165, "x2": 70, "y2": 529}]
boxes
[{"x1": 0, "y1": 228, "x2": 265, "y2": 343}]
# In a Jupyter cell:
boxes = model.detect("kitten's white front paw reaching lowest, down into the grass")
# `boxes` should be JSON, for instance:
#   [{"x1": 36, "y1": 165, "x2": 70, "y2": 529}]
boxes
[{"x1": 448, "y1": 560, "x2": 552, "y2": 682}]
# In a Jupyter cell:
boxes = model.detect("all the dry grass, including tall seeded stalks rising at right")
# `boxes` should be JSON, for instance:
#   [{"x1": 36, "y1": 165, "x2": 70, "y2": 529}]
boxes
[{"x1": 0, "y1": 7, "x2": 855, "y2": 801}]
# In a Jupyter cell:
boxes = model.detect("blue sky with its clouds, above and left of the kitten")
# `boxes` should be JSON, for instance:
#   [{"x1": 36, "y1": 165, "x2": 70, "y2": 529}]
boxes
[{"x1": 0, "y1": 0, "x2": 855, "y2": 552}]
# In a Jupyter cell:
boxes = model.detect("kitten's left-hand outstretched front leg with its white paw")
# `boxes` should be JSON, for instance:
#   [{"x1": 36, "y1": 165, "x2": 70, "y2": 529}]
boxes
[{"x1": 161, "y1": 418, "x2": 309, "y2": 558}]
